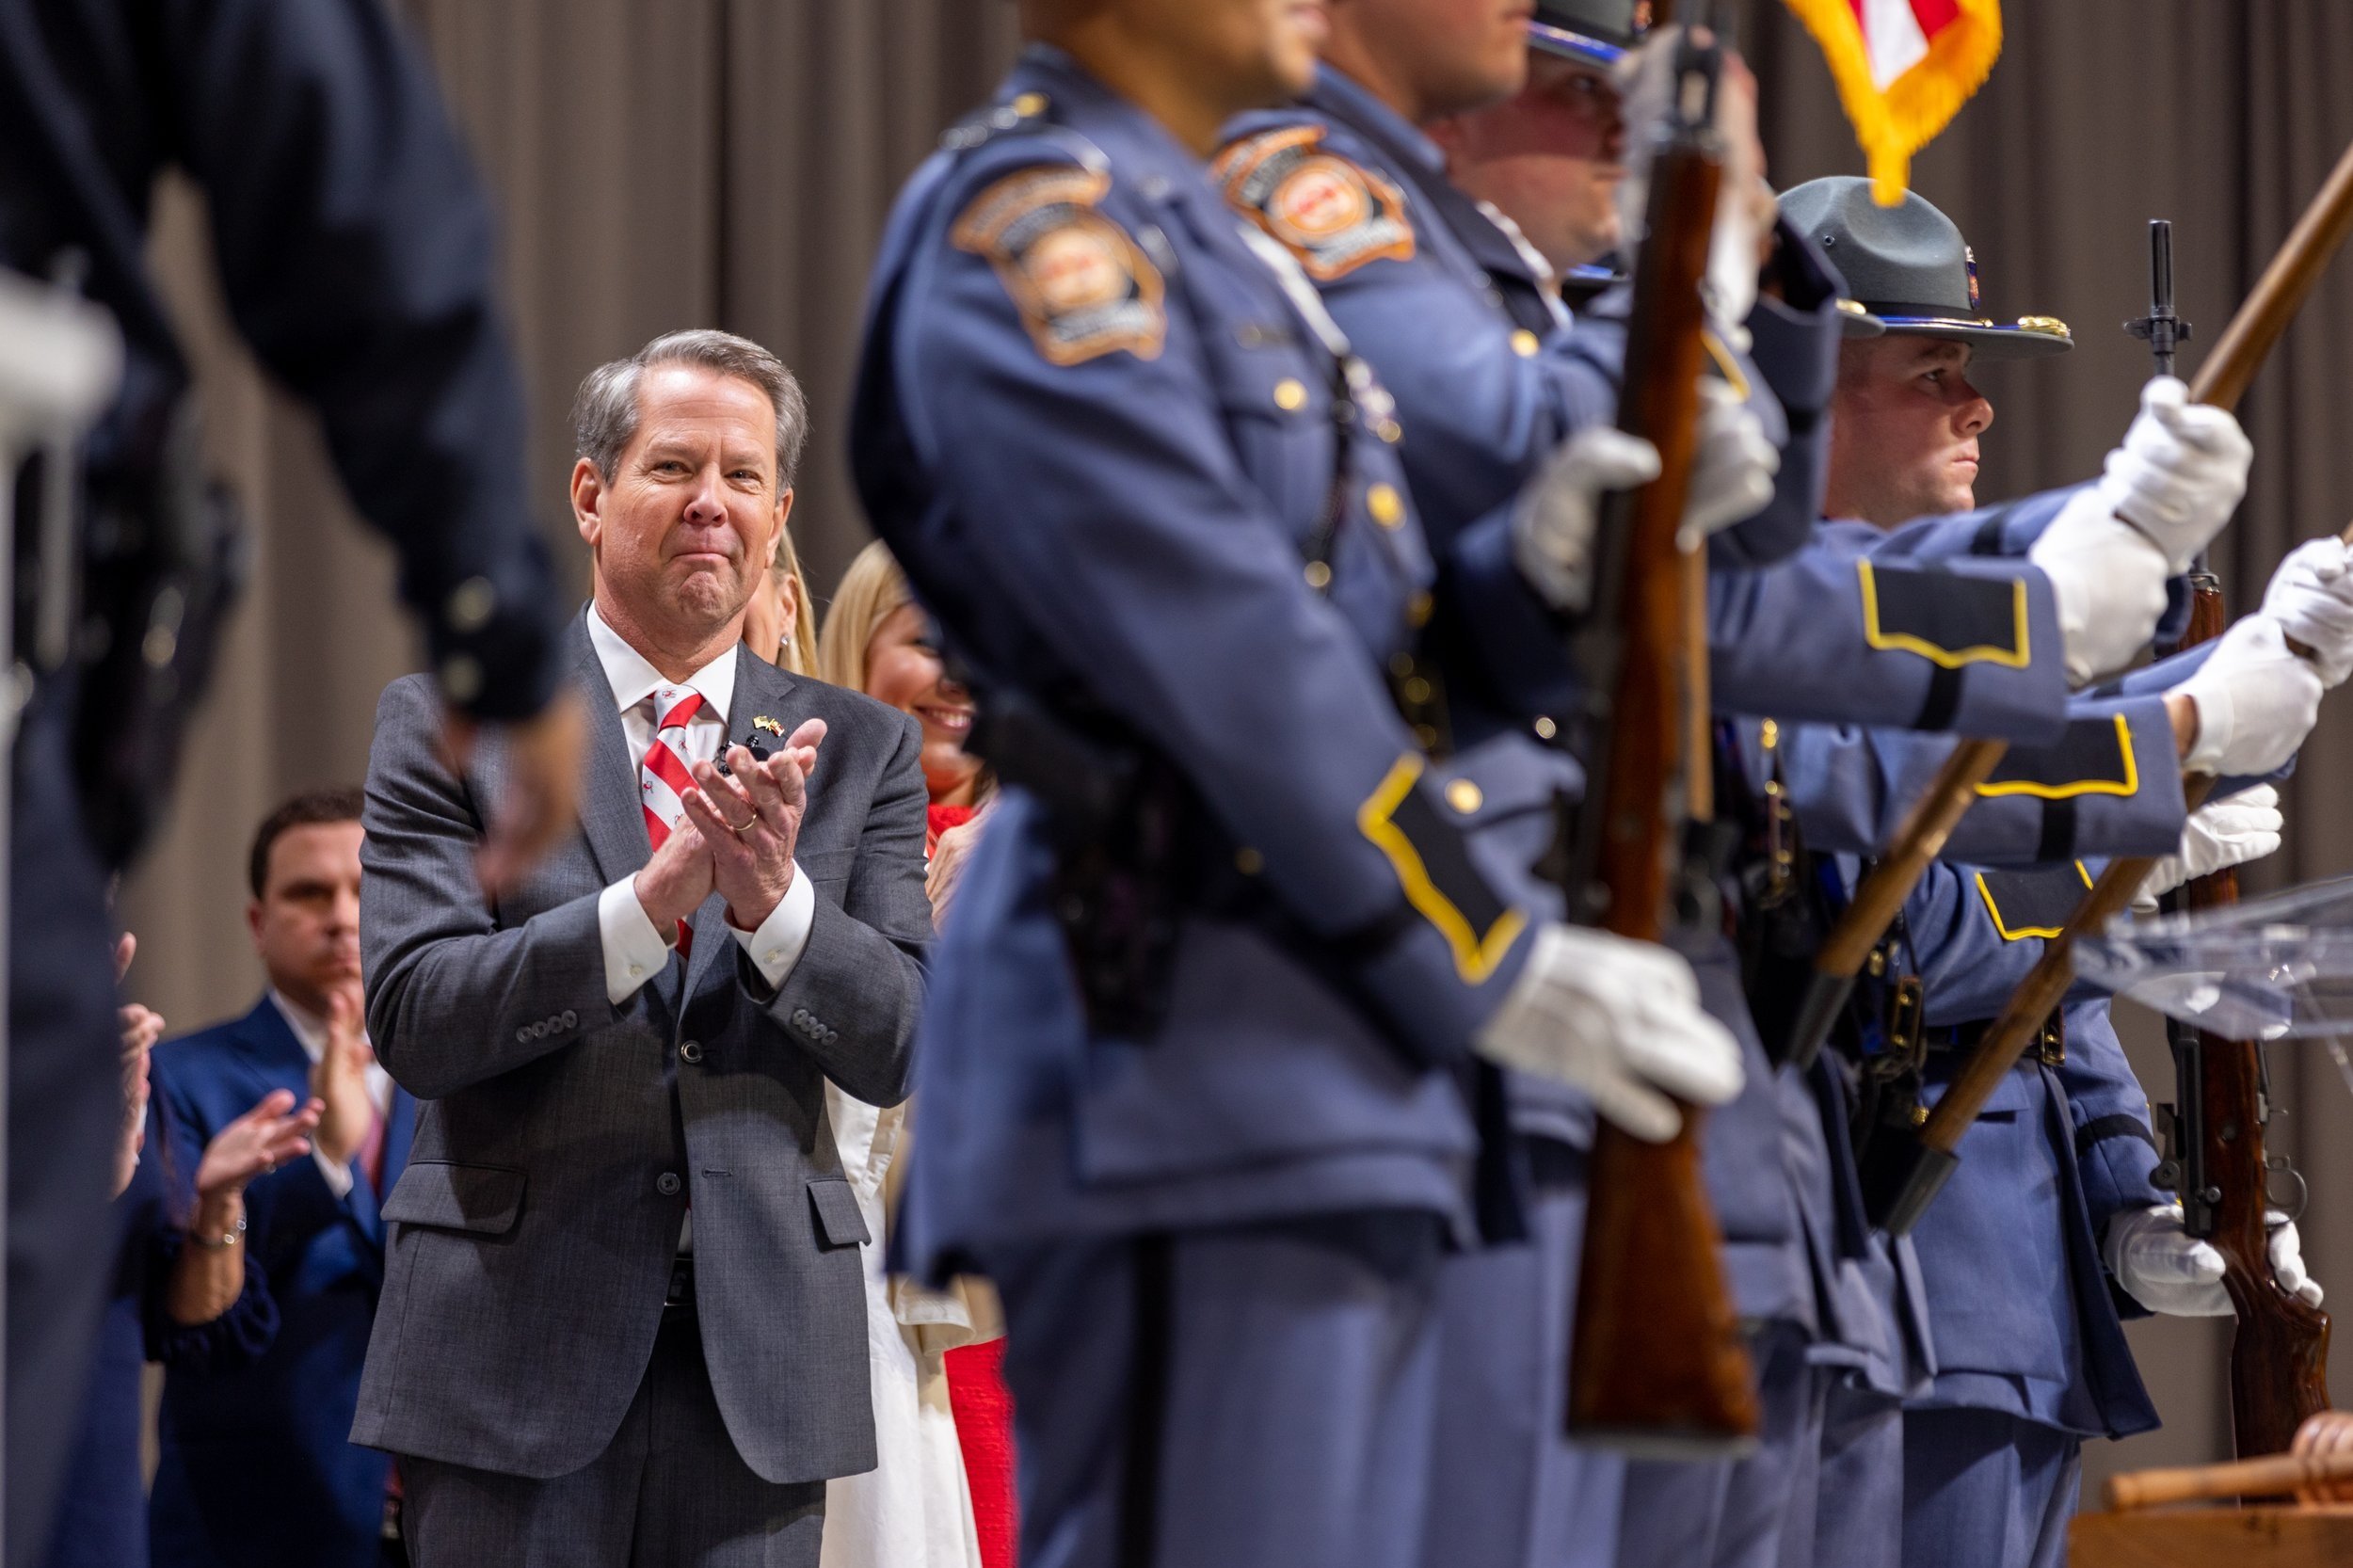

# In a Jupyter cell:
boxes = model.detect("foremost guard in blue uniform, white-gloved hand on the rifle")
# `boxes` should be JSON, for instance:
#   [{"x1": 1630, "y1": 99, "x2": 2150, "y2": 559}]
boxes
[{"x1": 852, "y1": 0, "x2": 1739, "y2": 1568}]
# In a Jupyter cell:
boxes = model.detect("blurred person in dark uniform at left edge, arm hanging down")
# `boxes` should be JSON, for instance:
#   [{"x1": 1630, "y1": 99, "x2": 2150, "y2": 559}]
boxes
[{"x1": 0, "y1": 0, "x2": 577, "y2": 1563}]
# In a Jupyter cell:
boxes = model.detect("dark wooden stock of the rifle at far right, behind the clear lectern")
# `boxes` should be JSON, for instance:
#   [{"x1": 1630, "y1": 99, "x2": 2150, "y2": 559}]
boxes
[{"x1": 2160, "y1": 572, "x2": 2329, "y2": 1455}]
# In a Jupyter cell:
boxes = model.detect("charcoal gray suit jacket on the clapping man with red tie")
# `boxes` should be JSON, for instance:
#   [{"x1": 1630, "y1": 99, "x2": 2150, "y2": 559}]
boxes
[{"x1": 351, "y1": 621, "x2": 932, "y2": 1480}]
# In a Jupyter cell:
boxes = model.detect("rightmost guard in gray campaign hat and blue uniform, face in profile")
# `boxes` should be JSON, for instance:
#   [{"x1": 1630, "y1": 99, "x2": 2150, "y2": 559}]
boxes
[{"x1": 1768, "y1": 182, "x2": 2337, "y2": 1565}]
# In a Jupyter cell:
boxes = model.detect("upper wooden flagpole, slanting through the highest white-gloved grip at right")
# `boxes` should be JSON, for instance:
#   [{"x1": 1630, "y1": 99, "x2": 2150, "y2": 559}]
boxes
[{"x1": 1784, "y1": 134, "x2": 2353, "y2": 1062}]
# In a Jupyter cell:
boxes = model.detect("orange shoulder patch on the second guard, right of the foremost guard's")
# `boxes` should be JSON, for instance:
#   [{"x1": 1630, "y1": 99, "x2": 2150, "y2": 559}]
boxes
[{"x1": 1212, "y1": 125, "x2": 1415, "y2": 282}]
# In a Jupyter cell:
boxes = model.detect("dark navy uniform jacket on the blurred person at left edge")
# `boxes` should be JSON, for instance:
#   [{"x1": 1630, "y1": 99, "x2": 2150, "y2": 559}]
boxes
[{"x1": 0, "y1": 0, "x2": 563, "y2": 718}]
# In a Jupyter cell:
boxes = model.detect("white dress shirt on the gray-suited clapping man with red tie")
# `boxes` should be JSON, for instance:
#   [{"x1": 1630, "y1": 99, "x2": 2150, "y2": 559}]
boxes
[{"x1": 588, "y1": 605, "x2": 817, "y2": 1008}]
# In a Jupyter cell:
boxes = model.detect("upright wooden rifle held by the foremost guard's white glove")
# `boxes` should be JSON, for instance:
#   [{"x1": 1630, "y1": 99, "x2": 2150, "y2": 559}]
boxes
[{"x1": 1562, "y1": 8, "x2": 1760, "y2": 1457}]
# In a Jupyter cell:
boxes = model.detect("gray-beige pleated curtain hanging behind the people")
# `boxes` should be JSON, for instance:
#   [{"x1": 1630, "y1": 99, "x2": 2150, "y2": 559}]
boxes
[{"x1": 125, "y1": 0, "x2": 2353, "y2": 1474}]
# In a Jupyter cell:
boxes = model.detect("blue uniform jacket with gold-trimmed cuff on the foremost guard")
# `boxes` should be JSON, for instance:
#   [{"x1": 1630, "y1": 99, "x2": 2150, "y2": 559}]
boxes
[{"x1": 852, "y1": 47, "x2": 1579, "y2": 1267}]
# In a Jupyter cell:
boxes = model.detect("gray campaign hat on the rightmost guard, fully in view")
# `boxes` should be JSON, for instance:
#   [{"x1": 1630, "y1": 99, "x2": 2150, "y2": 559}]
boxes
[{"x1": 1782, "y1": 174, "x2": 2075, "y2": 360}]
